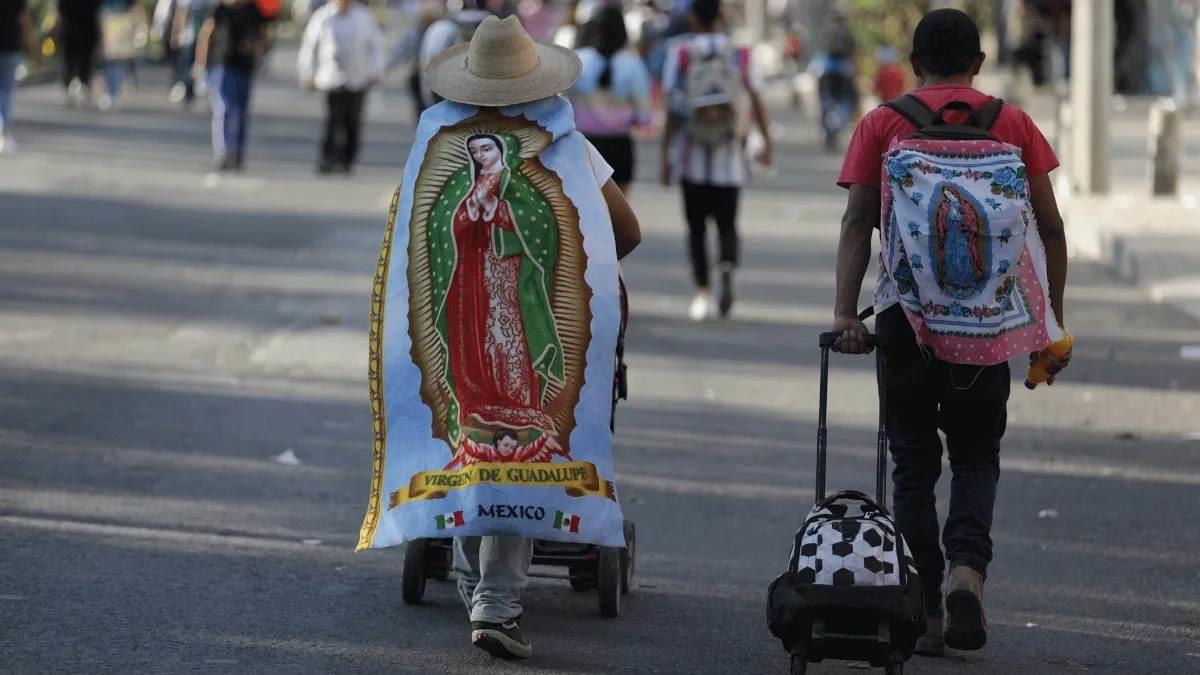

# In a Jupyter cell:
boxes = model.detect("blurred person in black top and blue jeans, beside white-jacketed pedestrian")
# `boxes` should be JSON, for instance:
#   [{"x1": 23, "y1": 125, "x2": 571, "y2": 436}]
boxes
[{"x1": 193, "y1": 0, "x2": 266, "y2": 171}]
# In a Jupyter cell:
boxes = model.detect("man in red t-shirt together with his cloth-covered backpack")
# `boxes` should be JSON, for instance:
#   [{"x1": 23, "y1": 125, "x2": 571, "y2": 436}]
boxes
[{"x1": 833, "y1": 10, "x2": 1067, "y2": 656}]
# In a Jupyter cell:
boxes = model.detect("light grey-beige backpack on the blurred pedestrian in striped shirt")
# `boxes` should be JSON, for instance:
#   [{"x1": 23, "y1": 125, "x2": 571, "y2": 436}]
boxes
[{"x1": 679, "y1": 44, "x2": 750, "y2": 147}]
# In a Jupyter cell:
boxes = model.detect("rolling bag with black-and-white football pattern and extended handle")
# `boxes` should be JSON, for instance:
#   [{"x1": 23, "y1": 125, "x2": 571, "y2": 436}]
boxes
[{"x1": 767, "y1": 333, "x2": 925, "y2": 675}]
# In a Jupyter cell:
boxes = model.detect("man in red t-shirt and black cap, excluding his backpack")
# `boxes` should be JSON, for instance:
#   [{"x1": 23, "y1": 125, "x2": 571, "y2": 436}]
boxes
[{"x1": 833, "y1": 10, "x2": 1067, "y2": 656}]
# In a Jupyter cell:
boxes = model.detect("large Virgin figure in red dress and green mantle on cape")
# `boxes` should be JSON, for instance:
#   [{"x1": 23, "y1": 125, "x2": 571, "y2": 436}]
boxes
[{"x1": 427, "y1": 133, "x2": 566, "y2": 461}]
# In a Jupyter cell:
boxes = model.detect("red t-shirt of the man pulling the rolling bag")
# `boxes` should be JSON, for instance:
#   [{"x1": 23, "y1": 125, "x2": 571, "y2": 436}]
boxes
[{"x1": 838, "y1": 84, "x2": 1058, "y2": 187}]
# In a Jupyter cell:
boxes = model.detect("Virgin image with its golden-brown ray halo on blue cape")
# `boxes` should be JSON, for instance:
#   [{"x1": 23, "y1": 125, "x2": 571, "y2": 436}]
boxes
[{"x1": 409, "y1": 118, "x2": 588, "y2": 470}]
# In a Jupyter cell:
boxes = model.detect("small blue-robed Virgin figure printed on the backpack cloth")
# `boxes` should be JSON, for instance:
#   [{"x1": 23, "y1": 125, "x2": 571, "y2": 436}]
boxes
[{"x1": 930, "y1": 185, "x2": 986, "y2": 300}]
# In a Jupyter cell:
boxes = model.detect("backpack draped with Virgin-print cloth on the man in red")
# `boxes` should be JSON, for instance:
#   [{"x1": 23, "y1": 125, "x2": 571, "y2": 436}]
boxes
[{"x1": 880, "y1": 95, "x2": 1062, "y2": 365}]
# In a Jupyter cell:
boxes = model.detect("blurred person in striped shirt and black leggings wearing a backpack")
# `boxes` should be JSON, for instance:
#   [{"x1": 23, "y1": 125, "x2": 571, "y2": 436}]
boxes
[{"x1": 660, "y1": 0, "x2": 773, "y2": 321}]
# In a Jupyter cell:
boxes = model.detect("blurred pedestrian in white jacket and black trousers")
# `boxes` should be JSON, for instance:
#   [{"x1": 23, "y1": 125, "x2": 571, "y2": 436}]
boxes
[{"x1": 298, "y1": 0, "x2": 385, "y2": 174}]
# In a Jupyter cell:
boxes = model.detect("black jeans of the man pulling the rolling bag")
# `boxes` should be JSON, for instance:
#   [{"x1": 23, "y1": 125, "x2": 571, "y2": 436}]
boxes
[{"x1": 876, "y1": 306, "x2": 1010, "y2": 614}]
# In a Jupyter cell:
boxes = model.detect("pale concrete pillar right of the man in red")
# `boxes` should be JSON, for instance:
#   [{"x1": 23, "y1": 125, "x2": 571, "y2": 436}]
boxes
[{"x1": 1070, "y1": 0, "x2": 1114, "y2": 195}]
